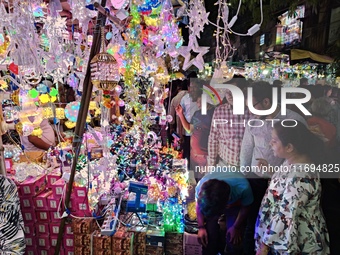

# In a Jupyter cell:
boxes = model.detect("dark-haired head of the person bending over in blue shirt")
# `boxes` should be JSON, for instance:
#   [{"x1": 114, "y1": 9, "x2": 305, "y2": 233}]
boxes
[{"x1": 197, "y1": 179, "x2": 230, "y2": 217}]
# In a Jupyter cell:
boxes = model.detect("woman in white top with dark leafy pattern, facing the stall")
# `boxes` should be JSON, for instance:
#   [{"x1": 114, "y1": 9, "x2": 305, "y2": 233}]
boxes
[{"x1": 255, "y1": 122, "x2": 329, "y2": 255}]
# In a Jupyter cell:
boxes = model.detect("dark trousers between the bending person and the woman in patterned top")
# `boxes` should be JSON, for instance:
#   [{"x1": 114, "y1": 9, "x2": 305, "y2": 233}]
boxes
[{"x1": 243, "y1": 175, "x2": 268, "y2": 255}]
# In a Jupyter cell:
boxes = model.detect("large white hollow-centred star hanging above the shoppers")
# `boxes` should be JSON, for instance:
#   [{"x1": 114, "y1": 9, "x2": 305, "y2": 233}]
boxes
[{"x1": 178, "y1": 35, "x2": 209, "y2": 71}]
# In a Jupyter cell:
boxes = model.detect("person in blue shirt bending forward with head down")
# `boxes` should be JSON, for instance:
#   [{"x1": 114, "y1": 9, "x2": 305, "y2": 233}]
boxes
[{"x1": 196, "y1": 172, "x2": 253, "y2": 255}]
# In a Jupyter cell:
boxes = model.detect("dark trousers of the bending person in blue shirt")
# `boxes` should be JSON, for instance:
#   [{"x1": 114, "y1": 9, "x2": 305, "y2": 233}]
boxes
[{"x1": 202, "y1": 206, "x2": 242, "y2": 255}]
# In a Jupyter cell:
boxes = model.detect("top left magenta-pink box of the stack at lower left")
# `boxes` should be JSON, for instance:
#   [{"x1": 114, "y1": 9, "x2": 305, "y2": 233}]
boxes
[{"x1": 19, "y1": 174, "x2": 47, "y2": 197}]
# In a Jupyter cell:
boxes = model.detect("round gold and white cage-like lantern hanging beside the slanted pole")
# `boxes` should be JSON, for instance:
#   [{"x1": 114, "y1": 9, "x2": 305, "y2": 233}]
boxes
[{"x1": 90, "y1": 27, "x2": 120, "y2": 91}]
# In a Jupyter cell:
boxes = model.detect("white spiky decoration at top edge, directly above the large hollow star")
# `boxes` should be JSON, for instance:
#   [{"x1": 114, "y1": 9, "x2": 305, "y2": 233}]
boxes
[{"x1": 188, "y1": 0, "x2": 210, "y2": 38}]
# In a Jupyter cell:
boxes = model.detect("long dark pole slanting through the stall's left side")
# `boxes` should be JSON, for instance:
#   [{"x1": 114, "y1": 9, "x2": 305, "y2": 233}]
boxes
[{"x1": 54, "y1": 0, "x2": 106, "y2": 255}]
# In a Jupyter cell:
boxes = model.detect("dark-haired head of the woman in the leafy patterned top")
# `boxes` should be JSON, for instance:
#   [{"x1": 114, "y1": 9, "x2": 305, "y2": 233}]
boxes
[{"x1": 271, "y1": 120, "x2": 325, "y2": 164}]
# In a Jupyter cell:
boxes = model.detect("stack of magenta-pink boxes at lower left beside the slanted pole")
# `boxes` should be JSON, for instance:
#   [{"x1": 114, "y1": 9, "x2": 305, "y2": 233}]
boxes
[{"x1": 18, "y1": 172, "x2": 77, "y2": 255}]
